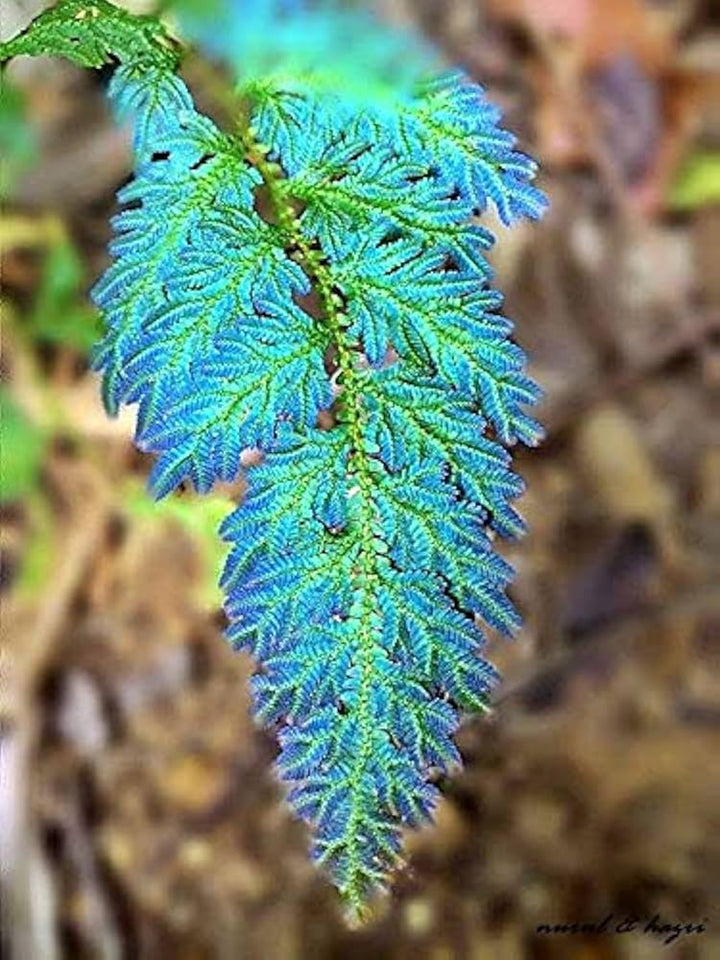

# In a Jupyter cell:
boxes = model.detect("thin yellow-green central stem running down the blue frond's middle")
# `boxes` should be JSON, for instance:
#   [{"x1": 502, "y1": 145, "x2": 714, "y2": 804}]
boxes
[{"x1": 242, "y1": 131, "x2": 380, "y2": 910}]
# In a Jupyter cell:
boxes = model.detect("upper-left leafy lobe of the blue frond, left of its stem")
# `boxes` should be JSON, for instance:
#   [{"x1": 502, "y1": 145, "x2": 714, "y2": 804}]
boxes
[{"x1": 93, "y1": 71, "x2": 332, "y2": 496}]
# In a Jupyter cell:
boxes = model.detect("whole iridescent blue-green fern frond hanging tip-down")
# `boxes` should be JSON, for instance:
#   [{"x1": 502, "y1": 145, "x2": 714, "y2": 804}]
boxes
[{"x1": 2, "y1": 0, "x2": 545, "y2": 910}]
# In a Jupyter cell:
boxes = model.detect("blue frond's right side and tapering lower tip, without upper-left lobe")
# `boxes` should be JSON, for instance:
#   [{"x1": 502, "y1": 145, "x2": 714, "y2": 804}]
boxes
[{"x1": 217, "y1": 75, "x2": 541, "y2": 908}]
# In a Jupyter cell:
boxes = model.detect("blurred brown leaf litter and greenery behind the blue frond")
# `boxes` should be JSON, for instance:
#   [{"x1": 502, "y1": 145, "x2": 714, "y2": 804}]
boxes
[{"x1": 0, "y1": 0, "x2": 720, "y2": 960}]
